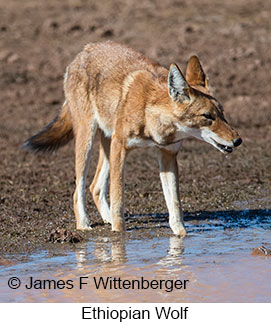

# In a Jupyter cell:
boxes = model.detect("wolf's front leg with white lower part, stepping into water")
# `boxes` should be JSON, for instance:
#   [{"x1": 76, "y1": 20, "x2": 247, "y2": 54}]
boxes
[{"x1": 158, "y1": 149, "x2": 186, "y2": 236}]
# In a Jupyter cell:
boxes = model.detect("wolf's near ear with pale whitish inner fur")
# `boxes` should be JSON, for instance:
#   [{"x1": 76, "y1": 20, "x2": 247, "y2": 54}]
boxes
[{"x1": 168, "y1": 64, "x2": 190, "y2": 102}]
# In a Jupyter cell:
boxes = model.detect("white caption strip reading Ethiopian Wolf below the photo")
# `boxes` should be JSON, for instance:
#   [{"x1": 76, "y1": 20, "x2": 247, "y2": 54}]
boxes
[{"x1": 0, "y1": 303, "x2": 270, "y2": 323}]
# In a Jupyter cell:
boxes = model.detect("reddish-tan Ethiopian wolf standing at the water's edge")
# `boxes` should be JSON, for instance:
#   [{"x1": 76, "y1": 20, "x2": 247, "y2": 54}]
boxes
[{"x1": 24, "y1": 41, "x2": 242, "y2": 236}]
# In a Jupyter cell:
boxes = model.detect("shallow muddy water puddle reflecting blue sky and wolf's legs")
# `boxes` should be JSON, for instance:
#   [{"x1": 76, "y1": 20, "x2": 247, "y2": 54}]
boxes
[{"x1": 0, "y1": 210, "x2": 271, "y2": 302}]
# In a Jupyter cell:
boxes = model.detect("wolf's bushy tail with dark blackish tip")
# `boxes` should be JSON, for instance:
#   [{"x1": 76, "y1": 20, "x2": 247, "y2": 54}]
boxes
[{"x1": 23, "y1": 102, "x2": 73, "y2": 152}]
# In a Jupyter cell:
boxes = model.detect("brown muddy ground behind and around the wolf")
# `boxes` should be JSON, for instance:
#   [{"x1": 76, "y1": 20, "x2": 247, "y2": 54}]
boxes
[{"x1": 0, "y1": 0, "x2": 271, "y2": 255}]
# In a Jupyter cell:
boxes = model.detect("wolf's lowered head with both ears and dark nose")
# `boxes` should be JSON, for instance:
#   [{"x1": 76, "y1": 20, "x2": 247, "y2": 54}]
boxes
[{"x1": 168, "y1": 56, "x2": 242, "y2": 153}]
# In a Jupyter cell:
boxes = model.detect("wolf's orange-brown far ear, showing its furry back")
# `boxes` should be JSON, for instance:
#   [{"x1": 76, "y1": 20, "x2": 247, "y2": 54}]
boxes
[{"x1": 185, "y1": 56, "x2": 209, "y2": 89}]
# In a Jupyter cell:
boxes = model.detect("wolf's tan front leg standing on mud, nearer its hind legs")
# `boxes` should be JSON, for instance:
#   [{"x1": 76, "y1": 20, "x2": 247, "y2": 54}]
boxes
[{"x1": 110, "y1": 135, "x2": 127, "y2": 231}]
